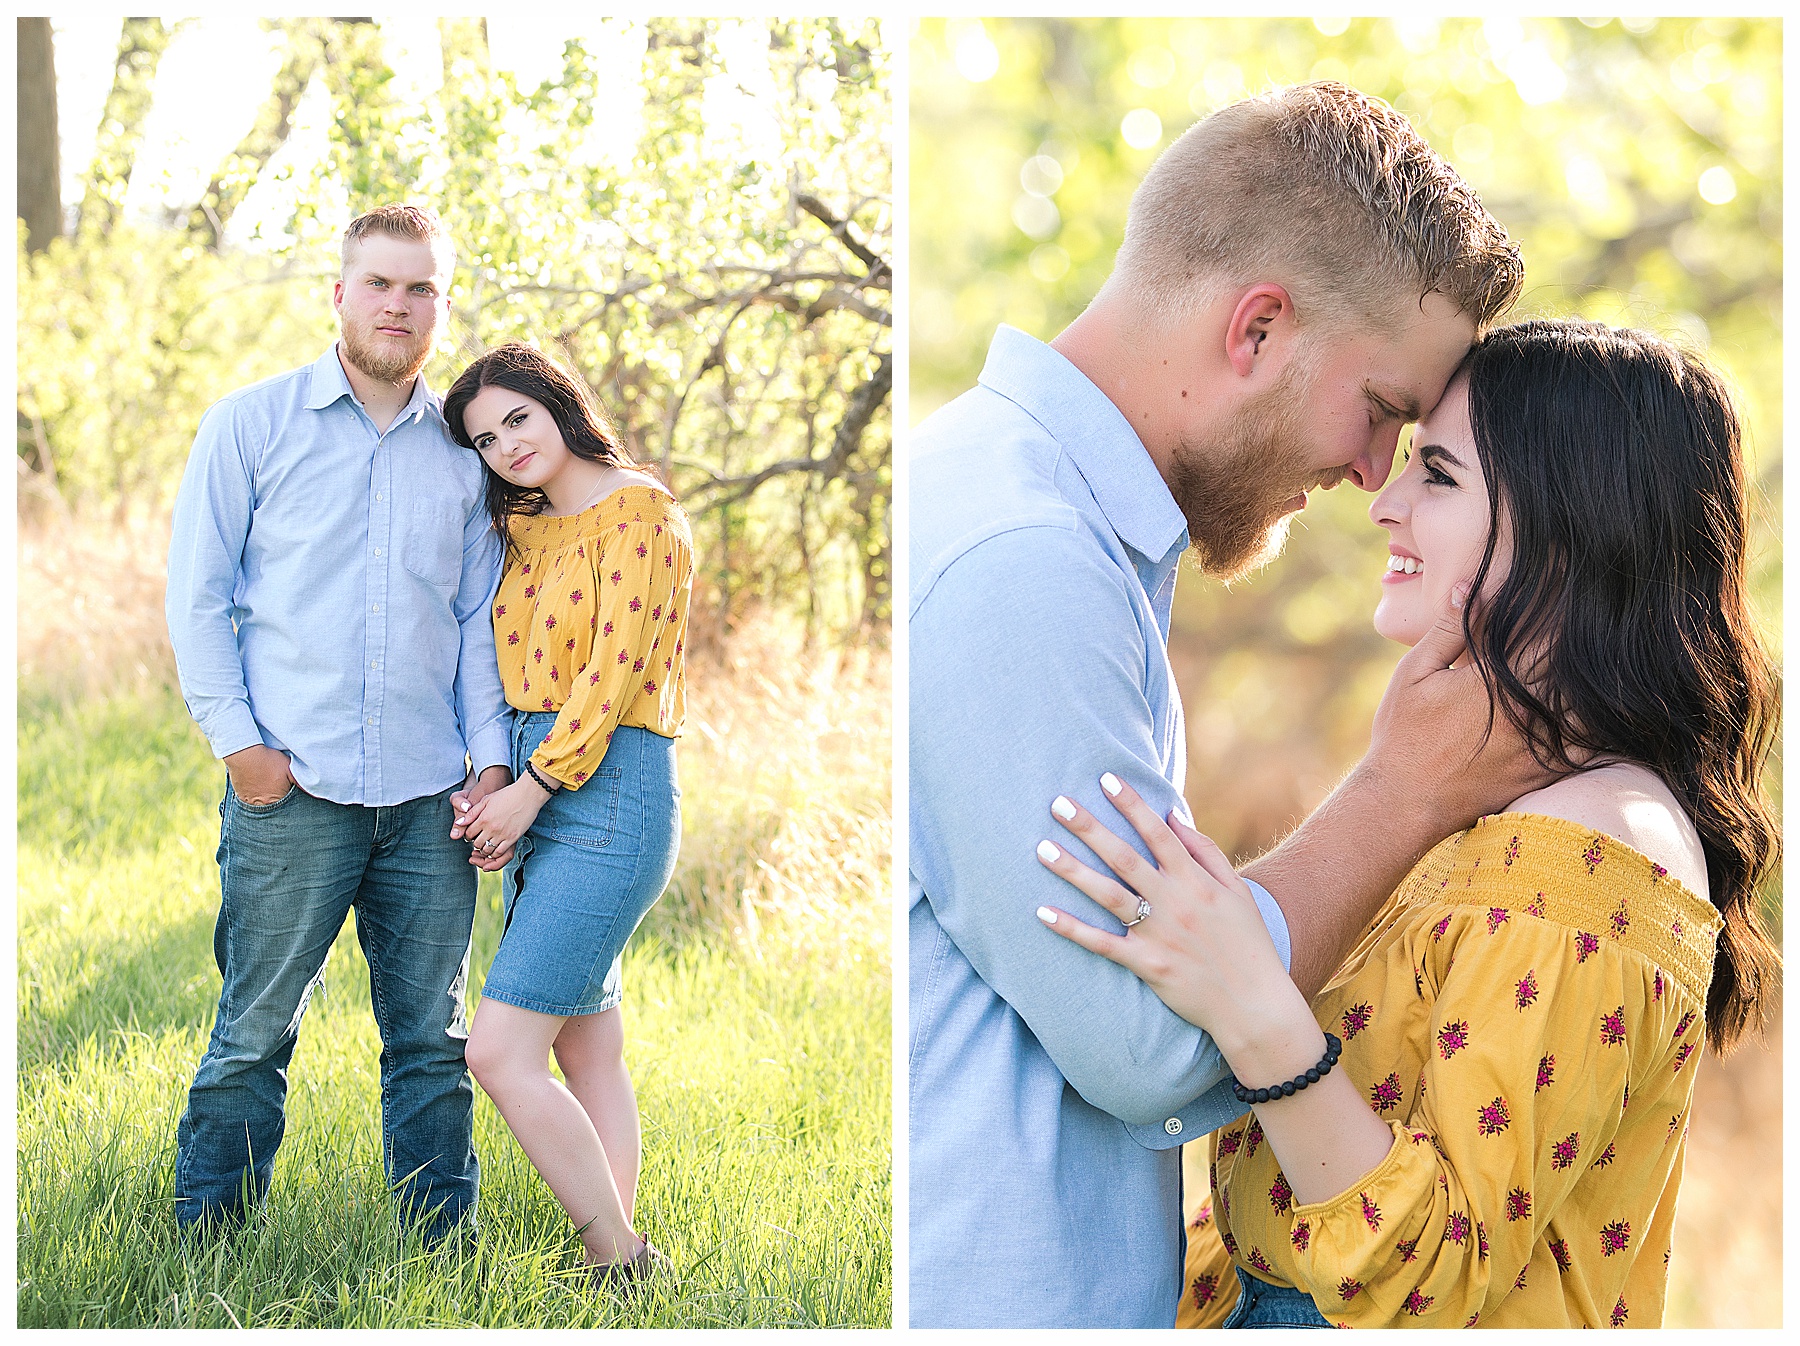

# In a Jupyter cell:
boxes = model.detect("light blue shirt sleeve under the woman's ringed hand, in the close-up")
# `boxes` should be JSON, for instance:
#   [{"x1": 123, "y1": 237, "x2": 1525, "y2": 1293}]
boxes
[{"x1": 909, "y1": 525, "x2": 1242, "y2": 1122}]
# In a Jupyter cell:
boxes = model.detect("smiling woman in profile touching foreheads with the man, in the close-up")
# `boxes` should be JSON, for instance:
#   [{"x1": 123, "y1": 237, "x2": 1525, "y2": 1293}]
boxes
[{"x1": 1039, "y1": 322, "x2": 1778, "y2": 1326}]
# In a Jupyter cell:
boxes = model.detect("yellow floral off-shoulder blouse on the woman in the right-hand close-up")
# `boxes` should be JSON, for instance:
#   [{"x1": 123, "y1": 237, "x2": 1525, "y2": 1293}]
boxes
[{"x1": 1179, "y1": 813, "x2": 1719, "y2": 1328}]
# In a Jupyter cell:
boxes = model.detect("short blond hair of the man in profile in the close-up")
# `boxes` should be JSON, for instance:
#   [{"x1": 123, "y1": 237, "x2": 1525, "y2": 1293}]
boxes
[{"x1": 1107, "y1": 81, "x2": 1525, "y2": 329}]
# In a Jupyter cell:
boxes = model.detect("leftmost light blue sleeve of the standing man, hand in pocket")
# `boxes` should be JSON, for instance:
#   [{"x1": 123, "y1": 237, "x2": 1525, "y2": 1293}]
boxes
[{"x1": 164, "y1": 401, "x2": 263, "y2": 758}]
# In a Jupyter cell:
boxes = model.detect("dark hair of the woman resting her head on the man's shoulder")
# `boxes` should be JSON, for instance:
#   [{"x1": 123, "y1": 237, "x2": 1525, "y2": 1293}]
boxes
[{"x1": 445, "y1": 342, "x2": 637, "y2": 554}]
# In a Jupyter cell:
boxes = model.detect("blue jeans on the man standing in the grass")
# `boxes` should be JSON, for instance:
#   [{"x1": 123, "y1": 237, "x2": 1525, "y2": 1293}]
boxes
[{"x1": 175, "y1": 785, "x2": 479, "y2": 1238}]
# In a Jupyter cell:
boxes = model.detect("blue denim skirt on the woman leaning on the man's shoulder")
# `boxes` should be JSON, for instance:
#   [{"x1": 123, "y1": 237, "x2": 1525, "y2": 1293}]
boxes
[{"x1": 481, "y1": 711, "x2": 680, "y2": 1018}]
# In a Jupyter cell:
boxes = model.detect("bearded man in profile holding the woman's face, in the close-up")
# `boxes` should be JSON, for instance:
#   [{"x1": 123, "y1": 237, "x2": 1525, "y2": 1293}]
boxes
[{"x1": 909, "y1": 85, "x2": 1543, "y2": 1326}]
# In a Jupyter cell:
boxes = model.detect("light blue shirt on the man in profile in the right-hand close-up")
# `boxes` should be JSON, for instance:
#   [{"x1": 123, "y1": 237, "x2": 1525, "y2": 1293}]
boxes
[{"x1": 907, "y1": 328, "x2": 1289, "y2": 1328}]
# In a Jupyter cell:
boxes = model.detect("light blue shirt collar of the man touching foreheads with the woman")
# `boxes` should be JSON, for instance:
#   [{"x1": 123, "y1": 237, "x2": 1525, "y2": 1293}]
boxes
[{"x1": 981, "y1": 324, "x2": 1188, "y2": 561}]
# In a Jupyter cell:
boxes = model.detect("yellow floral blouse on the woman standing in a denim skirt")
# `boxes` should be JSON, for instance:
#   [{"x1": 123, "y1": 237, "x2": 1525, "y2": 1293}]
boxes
[{"x1": 493, "y1": 486, "x2": 693, "y2": 788}]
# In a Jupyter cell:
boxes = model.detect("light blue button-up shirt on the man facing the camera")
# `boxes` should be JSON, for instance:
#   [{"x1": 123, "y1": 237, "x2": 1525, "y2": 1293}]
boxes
[{"x1": 167, "y1": 345, "x2": 509, "y2": 806}]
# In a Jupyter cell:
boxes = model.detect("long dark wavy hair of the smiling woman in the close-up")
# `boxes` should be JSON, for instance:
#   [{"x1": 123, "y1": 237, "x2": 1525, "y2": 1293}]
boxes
[{"x1": 1463, "y1": 320, "x2": 1780, "y2": 1051}]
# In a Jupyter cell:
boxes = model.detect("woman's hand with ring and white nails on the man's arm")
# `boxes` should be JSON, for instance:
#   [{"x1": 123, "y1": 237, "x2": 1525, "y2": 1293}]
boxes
[{"x1": 1037, "y1": 772, "x2": 1323, "y2": 1087}]
